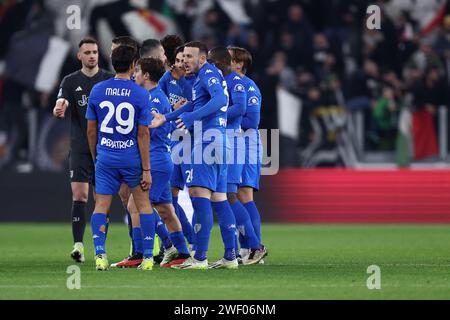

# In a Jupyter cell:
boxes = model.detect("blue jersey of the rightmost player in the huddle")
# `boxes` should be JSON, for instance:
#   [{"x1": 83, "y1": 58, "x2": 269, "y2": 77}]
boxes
[{"x1": 241, "y1": 76, "x2": 262, "y2": 129}]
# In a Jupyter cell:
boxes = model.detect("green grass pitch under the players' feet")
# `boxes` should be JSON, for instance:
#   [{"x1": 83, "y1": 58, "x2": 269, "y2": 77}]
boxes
[{"x1": 0, "y1": 223, "x2": 450, "y2": 300}]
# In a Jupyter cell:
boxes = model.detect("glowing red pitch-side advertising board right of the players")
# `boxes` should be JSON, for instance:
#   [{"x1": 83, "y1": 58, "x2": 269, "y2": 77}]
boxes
[{"x1": 257, "y1": 169, "x2": 450, "y2": 223}]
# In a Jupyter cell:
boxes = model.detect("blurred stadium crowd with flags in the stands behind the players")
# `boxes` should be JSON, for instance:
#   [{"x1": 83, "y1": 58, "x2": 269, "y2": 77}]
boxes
[{"x1": 0, "y1": 0, "x2": 450, "y2": 171}]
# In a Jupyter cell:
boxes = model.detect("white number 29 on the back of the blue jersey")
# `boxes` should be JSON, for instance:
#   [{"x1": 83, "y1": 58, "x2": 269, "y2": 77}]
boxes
[{"x1": 99, "y1": 101, "x2": 135, "y2": 134}]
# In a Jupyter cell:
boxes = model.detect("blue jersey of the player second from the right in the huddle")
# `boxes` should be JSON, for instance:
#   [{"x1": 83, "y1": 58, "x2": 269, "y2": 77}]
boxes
[{"x1": 225, "y1": 72, "x2": 247, "y2": 130}]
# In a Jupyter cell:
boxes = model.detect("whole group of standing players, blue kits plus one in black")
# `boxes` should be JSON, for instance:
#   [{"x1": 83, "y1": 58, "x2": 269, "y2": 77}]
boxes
[{"x1": 53, "y1": 35, "x2": 267, "y2": 270}]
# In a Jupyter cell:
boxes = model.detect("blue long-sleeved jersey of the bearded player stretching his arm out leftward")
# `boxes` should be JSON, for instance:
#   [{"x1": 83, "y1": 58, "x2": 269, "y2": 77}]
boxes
[{"x1": 192, "y1": 63, "x2": 228, "y2": 133}]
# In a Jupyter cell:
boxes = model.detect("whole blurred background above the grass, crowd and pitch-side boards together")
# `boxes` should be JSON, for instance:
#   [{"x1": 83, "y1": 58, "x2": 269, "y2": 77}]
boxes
[{"x1": 0, "y1": 0, "x2": 450, "y2": 222}]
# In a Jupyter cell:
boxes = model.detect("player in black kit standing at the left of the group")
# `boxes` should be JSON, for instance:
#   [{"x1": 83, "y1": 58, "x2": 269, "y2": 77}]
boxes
[{"x1": 53, "y1": 38, "x2": 113, "y2": 262}]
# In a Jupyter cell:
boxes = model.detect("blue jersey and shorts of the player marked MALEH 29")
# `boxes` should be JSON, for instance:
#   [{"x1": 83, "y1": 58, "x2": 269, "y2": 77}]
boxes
[{"x1": 86, "y1": 78, "x2": 151, "y2": 195}]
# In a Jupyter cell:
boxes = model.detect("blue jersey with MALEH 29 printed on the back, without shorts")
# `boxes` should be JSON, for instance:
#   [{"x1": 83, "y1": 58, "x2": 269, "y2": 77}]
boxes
[{"x1": 86, "y1": 78, "x2": 151, "y2": 168}]
